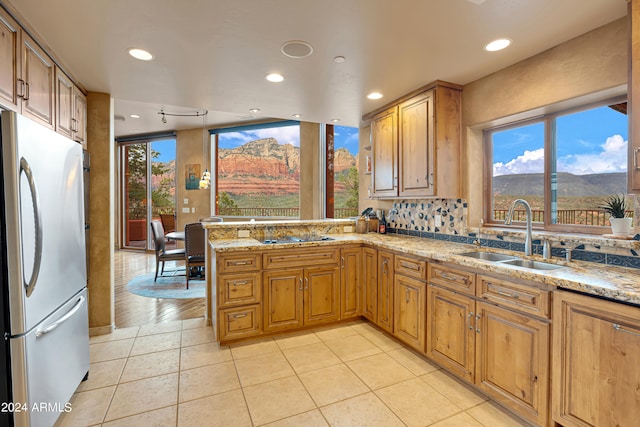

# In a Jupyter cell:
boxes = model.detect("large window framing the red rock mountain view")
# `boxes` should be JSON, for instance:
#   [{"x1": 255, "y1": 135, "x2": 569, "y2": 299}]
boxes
[{"x1": 215, "y1": 121, "x2": 300, "y2": 218}]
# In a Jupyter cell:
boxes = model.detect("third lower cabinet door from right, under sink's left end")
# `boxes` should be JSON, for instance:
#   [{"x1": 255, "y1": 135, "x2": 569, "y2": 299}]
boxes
[{"x1": 426, "y1": 284, "x2": 476, "y2": 382}]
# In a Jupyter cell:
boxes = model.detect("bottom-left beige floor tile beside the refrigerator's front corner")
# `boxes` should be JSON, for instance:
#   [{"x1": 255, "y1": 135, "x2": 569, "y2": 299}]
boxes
[{"x1": 56, "y1": 386, "x2": 116, "y2": 427}]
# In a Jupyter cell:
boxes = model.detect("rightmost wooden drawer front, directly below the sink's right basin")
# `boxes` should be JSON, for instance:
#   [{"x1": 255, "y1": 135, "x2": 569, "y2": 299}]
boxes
[{"x1": 476, "y1": 275, "x2": 550, "y2": 318}]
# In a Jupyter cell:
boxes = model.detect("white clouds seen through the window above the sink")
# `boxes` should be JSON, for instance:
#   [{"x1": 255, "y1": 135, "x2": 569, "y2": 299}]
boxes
[{"x1": 493, "y1": 135, "x2": 627, "y2": 176}]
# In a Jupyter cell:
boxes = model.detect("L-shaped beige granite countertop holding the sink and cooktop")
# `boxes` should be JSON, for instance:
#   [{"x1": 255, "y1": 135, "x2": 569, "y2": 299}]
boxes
[{"x1": 210, "y1": 233, "x2": 640, "y2": 306}]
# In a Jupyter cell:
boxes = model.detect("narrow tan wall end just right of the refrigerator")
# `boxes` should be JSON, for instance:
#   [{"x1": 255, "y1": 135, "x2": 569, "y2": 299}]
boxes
[{"x1": 87, "y1": 92, "x2": 117, "y2": 335}]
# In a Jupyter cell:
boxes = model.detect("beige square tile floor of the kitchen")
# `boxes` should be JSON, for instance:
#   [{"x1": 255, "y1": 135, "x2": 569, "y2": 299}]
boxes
[{"x1": 56, "y1": 319, "x2": 522, "y2": 427}]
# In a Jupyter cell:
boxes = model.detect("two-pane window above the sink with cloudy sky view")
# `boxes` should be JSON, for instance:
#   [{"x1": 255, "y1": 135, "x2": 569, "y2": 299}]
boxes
[{"x1": 485, "y1": 100, "x2": 628, "y2": 233}]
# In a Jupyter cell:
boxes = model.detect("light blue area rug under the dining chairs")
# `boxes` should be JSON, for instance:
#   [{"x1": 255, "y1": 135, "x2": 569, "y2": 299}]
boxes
[{"x1": 127, "y1": 269, "x2": 206, "y2": 299}]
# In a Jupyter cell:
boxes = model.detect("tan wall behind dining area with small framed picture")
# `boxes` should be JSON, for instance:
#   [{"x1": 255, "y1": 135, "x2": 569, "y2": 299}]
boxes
[{"x1": 176, "y1": 128, "x2": 212, "y2": 230}]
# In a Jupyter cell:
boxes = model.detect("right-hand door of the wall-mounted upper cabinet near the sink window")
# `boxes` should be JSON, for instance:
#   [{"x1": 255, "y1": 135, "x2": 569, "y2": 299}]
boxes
[{"x1": 398, "y1": 91, "x2": 436, "y2": 197}]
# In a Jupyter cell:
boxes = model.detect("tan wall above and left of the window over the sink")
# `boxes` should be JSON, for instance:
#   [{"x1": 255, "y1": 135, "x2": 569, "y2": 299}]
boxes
[{"x1": 462, "y1": 17, "x2": 628, "y2": 226}]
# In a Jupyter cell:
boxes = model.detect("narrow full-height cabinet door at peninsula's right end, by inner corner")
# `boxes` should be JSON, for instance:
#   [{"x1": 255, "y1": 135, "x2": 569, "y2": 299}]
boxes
[{"x1": 340, "y1": 248, "x2": 362, "y2": 319}]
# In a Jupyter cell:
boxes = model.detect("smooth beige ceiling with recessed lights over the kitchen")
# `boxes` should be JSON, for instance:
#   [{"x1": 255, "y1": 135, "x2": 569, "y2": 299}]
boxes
[{"x1": 0, "y1": 0, "x2": 627, "y2": 136}]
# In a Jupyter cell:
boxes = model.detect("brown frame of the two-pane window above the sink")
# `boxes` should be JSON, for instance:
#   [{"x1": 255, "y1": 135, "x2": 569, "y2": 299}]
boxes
[{"x1": 482, "y1": 94, "x2": 630, "y2": 234}]
